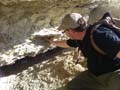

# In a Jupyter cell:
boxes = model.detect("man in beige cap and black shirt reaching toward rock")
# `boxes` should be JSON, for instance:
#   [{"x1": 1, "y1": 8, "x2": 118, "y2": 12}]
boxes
[{"x1": 49, "y1": 13, "x2": 120, "y2": 90}]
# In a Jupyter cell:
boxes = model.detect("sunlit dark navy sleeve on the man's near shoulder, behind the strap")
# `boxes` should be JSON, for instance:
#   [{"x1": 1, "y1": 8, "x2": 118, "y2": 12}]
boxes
[{"x1": 93, "y1": 28, "x2": 120, "y2": 58}]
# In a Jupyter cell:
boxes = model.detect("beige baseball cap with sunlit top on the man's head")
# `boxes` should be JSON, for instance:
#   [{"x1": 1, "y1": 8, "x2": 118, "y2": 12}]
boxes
[{"x1": 58, "y1": 13, "x2": 82, "y2": 30}]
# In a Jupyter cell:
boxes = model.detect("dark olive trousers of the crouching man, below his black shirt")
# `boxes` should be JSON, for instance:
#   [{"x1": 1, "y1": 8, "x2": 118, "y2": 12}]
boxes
[{"x1": 57, "y1": 70, "x2": 120, "y2": 90}]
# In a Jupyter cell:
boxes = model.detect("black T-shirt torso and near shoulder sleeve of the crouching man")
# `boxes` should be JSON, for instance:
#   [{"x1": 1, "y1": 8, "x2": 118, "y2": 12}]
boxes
[{"x1": 82, "y1": 23, "x2": 120, "y2": 75}]
